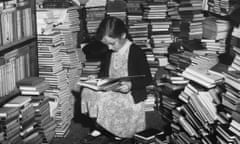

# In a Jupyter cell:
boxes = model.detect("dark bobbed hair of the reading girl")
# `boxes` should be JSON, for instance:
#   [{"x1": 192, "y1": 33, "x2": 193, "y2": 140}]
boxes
[{"x1": 96, "y1": 16, "x2": 128, "y2": 40}]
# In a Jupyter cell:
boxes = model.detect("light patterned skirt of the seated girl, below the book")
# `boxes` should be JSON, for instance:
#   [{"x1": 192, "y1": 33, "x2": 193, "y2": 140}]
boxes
[{"x1": 81, "y1": 88, "x2": 145, "y2": 138}]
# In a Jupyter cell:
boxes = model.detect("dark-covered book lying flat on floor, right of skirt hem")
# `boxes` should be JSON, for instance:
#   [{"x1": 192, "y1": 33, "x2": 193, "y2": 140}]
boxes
[{"x1": 134, "y1": 128, "x2": 164, "y2": 140}]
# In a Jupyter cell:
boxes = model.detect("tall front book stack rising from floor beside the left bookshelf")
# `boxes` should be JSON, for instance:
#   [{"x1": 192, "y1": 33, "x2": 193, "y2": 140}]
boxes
[{"x1": 38, "y1": 32, "x2": 73, "y2": 137}]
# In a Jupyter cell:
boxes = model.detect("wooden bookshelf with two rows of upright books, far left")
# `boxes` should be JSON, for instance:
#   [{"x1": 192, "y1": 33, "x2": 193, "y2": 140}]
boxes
[{"x1": 0, "y1": 0, "x2": 38, "y2": 106}]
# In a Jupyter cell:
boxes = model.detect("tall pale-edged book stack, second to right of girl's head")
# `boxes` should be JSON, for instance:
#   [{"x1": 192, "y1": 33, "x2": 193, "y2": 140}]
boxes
[{"x1": 143, "y1": 2, "x2": 173, "y2": 57}]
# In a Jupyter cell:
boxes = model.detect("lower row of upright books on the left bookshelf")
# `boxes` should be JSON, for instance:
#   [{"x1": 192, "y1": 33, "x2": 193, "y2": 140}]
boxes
[{"x1": 0, "y1": 43, "x2": 35, "y2": 97}]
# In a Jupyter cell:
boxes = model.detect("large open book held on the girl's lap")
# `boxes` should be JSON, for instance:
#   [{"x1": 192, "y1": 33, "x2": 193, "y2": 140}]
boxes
[{"x1": 77, "y1": 75, "x2": 145, "y2": 91}]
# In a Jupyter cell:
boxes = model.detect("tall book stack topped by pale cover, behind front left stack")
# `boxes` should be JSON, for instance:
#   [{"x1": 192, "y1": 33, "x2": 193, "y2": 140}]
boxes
[{"x1": 48, "y1": 7, "x2": 81, "y2": 89}]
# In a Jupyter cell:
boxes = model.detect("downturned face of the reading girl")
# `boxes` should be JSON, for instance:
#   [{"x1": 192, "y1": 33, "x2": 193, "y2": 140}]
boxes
[{"x1": 102, "y1": 35, "x2": 126, "y2": 51}]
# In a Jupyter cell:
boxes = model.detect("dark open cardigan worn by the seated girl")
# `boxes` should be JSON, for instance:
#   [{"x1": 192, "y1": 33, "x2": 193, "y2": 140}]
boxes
[{"x1": 99, "y1": 44, "x2": 152, "y2": 103}]
